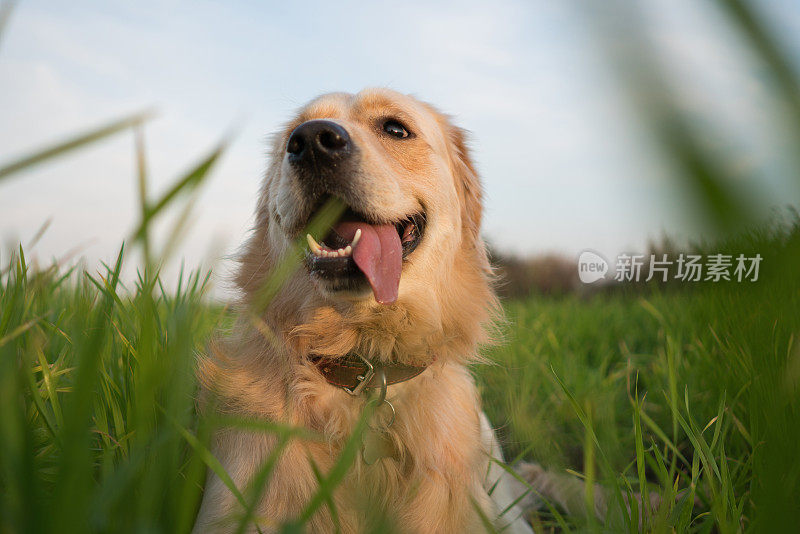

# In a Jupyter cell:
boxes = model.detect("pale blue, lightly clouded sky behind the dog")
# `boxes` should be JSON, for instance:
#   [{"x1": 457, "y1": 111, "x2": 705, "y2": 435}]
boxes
[{"x1": 0, "y1": 0, "x2": 800, "y2": 298}]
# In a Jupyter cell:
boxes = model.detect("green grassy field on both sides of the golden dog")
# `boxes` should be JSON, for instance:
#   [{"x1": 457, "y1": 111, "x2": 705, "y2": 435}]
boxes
[{"x1": 0, "y1": 220, "x2": 800, "y2": 532}]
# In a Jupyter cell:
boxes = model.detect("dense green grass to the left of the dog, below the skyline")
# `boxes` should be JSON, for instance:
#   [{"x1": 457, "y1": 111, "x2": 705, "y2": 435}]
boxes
[{"x1": 0, "y1": 252, "x2": 222, "y2": 532}]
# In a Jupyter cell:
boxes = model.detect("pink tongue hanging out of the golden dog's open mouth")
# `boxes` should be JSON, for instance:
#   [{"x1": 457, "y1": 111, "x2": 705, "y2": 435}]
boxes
[{"x1": 334, "y1": 221, "x2": 403, "y2": 304}]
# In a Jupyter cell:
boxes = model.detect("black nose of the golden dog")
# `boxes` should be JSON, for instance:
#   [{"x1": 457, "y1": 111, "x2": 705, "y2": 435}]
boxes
[{"x1": 286, "y1": 119, "x2": 351, "y2": 165}]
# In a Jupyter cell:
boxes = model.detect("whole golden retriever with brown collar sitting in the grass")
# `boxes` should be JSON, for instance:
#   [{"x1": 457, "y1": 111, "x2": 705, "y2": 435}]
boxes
[{"x1": 195, "y1": 88, "x2": 532, "y2": 534}]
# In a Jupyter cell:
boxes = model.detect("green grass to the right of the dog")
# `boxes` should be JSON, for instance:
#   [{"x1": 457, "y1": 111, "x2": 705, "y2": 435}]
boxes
[{"x1": 476, "y1": 227, "x2": 800, "y2": 532}]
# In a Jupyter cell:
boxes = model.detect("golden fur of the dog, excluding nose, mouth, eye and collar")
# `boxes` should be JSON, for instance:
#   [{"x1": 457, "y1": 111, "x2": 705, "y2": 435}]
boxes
[{"x1": 195, "y1": 89, "x2": 532, "y2": 533}]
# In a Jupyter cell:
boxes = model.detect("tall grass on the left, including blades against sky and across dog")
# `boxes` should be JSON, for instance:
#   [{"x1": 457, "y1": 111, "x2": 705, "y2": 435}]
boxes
[{"x1": 0, "y1": 94, "x2": 364, "y2": 532}]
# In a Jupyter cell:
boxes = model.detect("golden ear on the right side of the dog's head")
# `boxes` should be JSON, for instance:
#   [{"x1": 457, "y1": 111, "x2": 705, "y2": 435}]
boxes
[{"x1": 446, "y1": 124, "x2": 483, "y2": 241}]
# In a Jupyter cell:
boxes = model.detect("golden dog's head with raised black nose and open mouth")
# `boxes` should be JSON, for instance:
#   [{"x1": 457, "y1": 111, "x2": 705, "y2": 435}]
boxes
[{"x1": 239, "y1": 89, "x2": 496, "y2": 364}]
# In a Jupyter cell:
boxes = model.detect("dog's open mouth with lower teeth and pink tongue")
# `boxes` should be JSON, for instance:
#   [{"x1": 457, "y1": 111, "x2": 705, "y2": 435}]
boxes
[{"x1": 306, "y1": 209, "x2": 425, "y2": 304}]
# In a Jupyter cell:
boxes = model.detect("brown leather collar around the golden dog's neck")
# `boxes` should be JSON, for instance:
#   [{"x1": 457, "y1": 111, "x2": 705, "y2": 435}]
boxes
[{"x1": 309, "y1": 354, "x2": 428, "y2": 395}]
